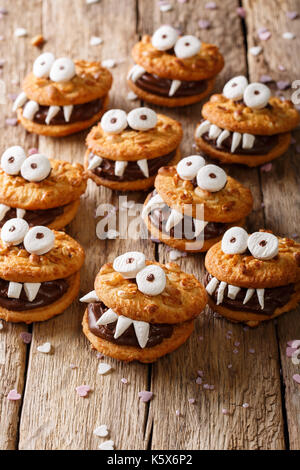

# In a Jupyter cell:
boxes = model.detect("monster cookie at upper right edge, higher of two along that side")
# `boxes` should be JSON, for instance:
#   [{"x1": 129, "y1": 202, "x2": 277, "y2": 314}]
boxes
[{"x1": 195, "y1": 76, "x2": 299, "y2": 167}]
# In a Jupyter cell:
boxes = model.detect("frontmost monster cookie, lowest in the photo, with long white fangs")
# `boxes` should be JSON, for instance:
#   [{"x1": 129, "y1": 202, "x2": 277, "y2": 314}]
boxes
[{"x1": 80, "y1": 252, "x2": 207, "y2": 362}]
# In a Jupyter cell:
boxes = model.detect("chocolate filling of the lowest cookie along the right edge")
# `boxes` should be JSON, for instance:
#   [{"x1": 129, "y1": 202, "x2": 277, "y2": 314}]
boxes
[{"x1": 204, "y1": 273, "x2": 295, "y2": 316}]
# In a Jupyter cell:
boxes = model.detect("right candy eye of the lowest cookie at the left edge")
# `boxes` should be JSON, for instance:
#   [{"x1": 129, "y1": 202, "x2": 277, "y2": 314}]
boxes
[{"x1": 24, "y1": 225, "x2": 55, "y2": 255}]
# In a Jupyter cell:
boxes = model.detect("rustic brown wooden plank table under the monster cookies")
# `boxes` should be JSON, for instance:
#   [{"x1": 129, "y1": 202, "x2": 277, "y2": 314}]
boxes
[{"x1": 0, "y1": 0, "x2": 300, "y2": 449}]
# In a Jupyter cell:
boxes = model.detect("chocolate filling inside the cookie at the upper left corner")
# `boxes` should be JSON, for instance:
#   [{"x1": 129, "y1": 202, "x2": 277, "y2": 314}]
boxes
[{"x1": 22, "y1": 99, "x2": 103, "y2": 126}]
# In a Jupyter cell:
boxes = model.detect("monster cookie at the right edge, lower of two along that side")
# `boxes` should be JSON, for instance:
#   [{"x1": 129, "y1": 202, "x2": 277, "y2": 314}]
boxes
[{"x1": 205, "y1": 227, "x2": 300, "y2": 326}]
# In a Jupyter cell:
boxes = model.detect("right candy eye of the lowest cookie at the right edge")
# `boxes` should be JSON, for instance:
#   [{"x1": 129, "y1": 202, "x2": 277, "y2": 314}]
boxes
[{"x1": 248, "y1": 232, "x2": 278, "y2": 260}]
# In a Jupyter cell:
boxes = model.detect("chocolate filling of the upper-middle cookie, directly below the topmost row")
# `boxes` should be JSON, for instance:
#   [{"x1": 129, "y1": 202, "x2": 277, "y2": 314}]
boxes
[{"x1": 89, "y1": 149, "x2": 176, "y2": 181}]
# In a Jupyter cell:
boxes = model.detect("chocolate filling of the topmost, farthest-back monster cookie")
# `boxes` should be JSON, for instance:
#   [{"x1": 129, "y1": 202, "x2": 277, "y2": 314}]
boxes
[{"x1": 135, "y1": 72, "x2": 207, "y2": 98}]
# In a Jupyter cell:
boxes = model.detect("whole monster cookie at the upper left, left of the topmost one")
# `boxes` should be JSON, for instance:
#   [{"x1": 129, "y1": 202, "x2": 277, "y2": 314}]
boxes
[{"x1": 13, "y1": 52, "x2": 112, "y2": 137}]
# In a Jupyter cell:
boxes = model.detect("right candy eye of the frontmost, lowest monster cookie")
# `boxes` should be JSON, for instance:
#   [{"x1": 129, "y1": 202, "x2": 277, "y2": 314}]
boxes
[{"x1": 136, "y1": 264, "x2": 167, "y2": 295}]
